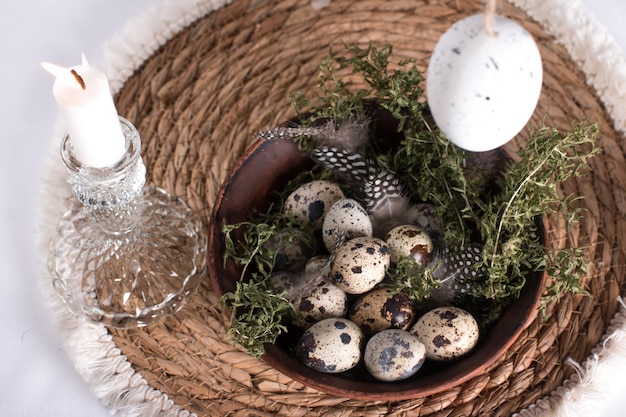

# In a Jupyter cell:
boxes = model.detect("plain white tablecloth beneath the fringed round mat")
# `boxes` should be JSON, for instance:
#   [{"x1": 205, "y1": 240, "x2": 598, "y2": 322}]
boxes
[{"x1": 0, "y1": 0, "x2": 626, "y2": 417}]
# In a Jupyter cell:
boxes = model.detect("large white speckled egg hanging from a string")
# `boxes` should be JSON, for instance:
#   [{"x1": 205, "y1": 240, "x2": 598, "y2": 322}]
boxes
[{"x1": 426, "y1": 14, "x2": 543, "y2": 152}]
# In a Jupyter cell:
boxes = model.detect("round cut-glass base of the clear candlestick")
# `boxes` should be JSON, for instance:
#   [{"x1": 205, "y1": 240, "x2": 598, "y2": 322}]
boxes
[{"x1": 49, "y1": 187, "x2": 206, "y2": 328}]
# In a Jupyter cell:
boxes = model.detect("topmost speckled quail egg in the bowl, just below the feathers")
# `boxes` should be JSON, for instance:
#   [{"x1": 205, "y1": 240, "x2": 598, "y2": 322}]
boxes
[{"x1": 283, "y1": 180, "x2": 344, "y2": 230}]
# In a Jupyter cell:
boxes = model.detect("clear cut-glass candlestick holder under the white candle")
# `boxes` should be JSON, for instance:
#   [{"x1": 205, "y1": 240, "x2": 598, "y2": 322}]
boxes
[{"x1": 48, "y1": 118, "x2": 207, "y2": 328}]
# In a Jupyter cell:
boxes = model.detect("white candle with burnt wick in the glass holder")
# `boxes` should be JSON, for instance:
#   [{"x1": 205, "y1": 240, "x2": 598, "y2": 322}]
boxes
[{"x1": 42, "y1": 56, "x2": 126, "y2": 168}]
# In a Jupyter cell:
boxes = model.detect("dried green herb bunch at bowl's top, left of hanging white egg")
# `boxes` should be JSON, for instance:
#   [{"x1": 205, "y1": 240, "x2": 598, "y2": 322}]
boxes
[{"x1": 292, "y1": 43, "x2": 478, "y2": 241}]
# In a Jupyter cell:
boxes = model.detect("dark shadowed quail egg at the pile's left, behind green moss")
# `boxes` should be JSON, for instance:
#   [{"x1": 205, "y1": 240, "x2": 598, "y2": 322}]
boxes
[{"x1": 263, "y1": 229, "x2": 316, "y2": 271}]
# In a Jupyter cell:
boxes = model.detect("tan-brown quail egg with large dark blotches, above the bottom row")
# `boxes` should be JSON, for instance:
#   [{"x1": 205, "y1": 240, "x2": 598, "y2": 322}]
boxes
[{"x1": 348, "y1": 288, "x2": 415, "y2": 335}]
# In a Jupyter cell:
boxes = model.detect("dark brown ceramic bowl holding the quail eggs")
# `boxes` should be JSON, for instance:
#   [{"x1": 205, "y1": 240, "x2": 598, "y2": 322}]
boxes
[{"x1": 209, "y1": 107, "x2": 546, "y2": 401}]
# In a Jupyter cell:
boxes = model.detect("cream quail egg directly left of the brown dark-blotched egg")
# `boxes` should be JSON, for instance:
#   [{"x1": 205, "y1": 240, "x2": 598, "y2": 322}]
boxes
[{"x1": 294, "y1": 281, "x2": 348, "y2": 329}]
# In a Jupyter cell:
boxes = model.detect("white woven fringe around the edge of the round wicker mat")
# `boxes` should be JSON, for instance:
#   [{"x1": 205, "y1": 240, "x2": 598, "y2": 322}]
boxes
[{"x1": 40, "y1": 0, "x2": 626, "y2": 417}]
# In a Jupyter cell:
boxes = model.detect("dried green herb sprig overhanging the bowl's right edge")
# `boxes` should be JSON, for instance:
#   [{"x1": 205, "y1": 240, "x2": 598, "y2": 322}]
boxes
[{"x1": 479, "y1": 123, "x2": 600, "y2": 298}]
